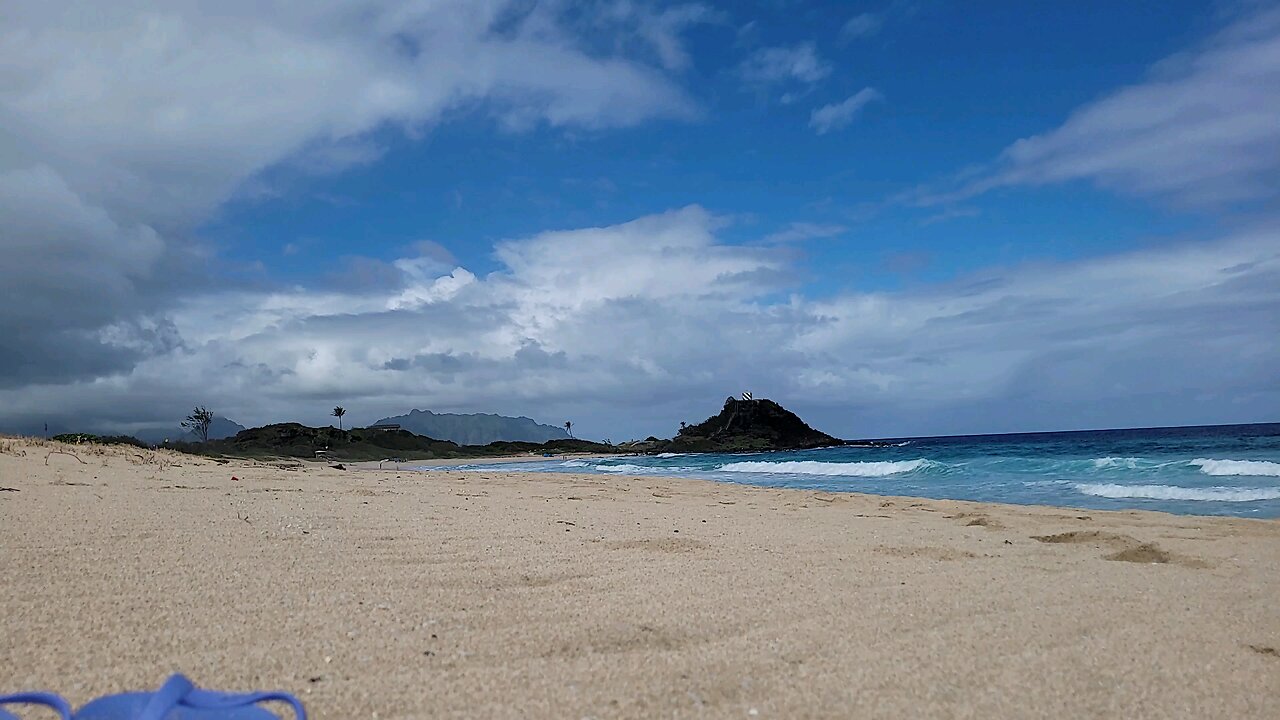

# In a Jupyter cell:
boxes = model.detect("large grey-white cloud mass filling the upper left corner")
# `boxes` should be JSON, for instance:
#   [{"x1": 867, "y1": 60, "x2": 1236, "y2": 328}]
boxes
[{"x1": 0, "y1": 0, "x2": 701, "y2": 384}]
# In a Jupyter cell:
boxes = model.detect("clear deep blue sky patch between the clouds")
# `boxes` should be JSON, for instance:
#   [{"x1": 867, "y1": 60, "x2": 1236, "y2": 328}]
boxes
[{"x1": 204, "y1": 3, "x2": 1219, "y2": 292}]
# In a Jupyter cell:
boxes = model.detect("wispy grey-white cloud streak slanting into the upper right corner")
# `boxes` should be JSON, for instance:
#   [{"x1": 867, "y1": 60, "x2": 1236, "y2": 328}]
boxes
[{"x1": 923, "y1": 9, "x2": 1280, "y2": 208}]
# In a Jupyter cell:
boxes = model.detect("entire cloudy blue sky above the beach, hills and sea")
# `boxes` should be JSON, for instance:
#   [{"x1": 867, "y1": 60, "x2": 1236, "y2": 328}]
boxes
[{"x1": 0, "y1": 0, "x2": 1280, "y2": 441}]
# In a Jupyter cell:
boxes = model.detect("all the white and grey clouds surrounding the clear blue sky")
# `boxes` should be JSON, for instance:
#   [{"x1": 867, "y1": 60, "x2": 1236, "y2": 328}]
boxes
[{"x1": 0, "y1": 0, "x2": 1280, "y2": 439}]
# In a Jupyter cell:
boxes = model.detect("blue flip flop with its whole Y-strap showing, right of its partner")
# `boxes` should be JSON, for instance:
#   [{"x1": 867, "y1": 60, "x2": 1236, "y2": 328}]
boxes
[{"x1": 73, "y1": 675, "x2": 307, "y2": 720}]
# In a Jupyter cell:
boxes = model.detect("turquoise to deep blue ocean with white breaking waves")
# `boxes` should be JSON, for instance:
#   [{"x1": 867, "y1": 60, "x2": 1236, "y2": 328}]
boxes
[{"x1": 430, "y1": 423, "x2": 1280, "y2": 518}]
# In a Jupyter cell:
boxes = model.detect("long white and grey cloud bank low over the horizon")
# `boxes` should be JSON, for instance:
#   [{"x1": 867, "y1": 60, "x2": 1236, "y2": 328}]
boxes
[{"x1": 0, "y1": 206, "x2": 1280, "y2": 439}]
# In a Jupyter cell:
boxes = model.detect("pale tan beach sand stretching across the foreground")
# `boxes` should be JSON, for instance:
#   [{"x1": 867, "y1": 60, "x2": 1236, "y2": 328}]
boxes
[{"x1": 0, "y1": 439, "x2": 1280, "y2": 719}]
